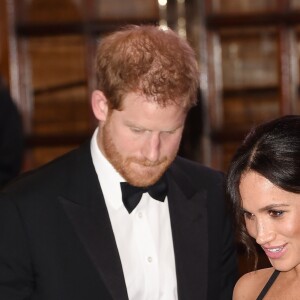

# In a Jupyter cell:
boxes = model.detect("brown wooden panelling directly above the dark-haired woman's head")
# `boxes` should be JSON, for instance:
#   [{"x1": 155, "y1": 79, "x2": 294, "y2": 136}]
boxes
[{"x1": 206, "y1": 0, "x2": 300, "y2": 171}]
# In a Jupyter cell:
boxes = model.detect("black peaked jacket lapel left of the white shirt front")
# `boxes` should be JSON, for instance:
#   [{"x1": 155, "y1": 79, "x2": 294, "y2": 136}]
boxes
[{"x1": 60, "y1": 143, "x2": 128, "y2": 300}]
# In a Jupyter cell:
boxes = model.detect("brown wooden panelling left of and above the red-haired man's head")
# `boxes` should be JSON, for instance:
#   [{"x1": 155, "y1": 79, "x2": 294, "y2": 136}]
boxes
[{"x1": 1, "y1": 0, "x2": 159, "y2": 171}]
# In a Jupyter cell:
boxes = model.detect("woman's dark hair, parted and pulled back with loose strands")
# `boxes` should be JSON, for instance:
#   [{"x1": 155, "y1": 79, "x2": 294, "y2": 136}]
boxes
[{"x1": 226, "y1": 115, "x2": 300, "y2": 268}]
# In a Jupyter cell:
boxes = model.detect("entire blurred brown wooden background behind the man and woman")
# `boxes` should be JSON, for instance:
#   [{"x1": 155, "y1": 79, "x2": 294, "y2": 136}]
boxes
[{"x1": 0, "y1": 0, "x2": 300, "y2": 273}]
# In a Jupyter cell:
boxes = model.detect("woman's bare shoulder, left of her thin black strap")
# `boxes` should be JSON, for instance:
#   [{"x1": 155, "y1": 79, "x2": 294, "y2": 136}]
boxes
[{"x1": 232, "y1": 268, "x2": 274, "y2": 300}]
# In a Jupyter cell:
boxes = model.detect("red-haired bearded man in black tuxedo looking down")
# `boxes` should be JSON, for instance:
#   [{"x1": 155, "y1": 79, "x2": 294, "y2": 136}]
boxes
[{"x1": 0, "y1": 25, "x2": 236, "y2": 300}]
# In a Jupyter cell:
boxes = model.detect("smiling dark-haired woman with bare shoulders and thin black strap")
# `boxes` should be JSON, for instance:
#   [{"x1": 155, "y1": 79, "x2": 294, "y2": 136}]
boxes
[{"x1": 227, "y1": 116, "x2": 300, "y2": 300}]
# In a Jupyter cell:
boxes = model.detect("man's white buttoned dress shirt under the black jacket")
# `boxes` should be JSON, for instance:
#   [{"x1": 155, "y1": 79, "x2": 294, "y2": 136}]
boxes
[{"x1": 91, "y1": 129, "x2": 178, "y2": 300}]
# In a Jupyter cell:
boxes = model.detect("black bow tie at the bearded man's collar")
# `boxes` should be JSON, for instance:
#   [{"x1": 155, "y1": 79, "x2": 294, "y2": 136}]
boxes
[{"x1": 121, "y1": 178, "x2": 168, "y2": 213}]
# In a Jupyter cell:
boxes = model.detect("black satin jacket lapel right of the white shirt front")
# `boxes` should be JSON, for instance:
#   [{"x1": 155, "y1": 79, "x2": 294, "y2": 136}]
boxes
[{"x1": 168, "y1": 166, "x2": 208, "y2": 300}]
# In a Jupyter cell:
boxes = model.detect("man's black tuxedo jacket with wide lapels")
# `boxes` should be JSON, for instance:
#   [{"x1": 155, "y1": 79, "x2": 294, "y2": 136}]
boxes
[{"x1": 0, "y1": 143, "x2": 236, "y2": 300}]
